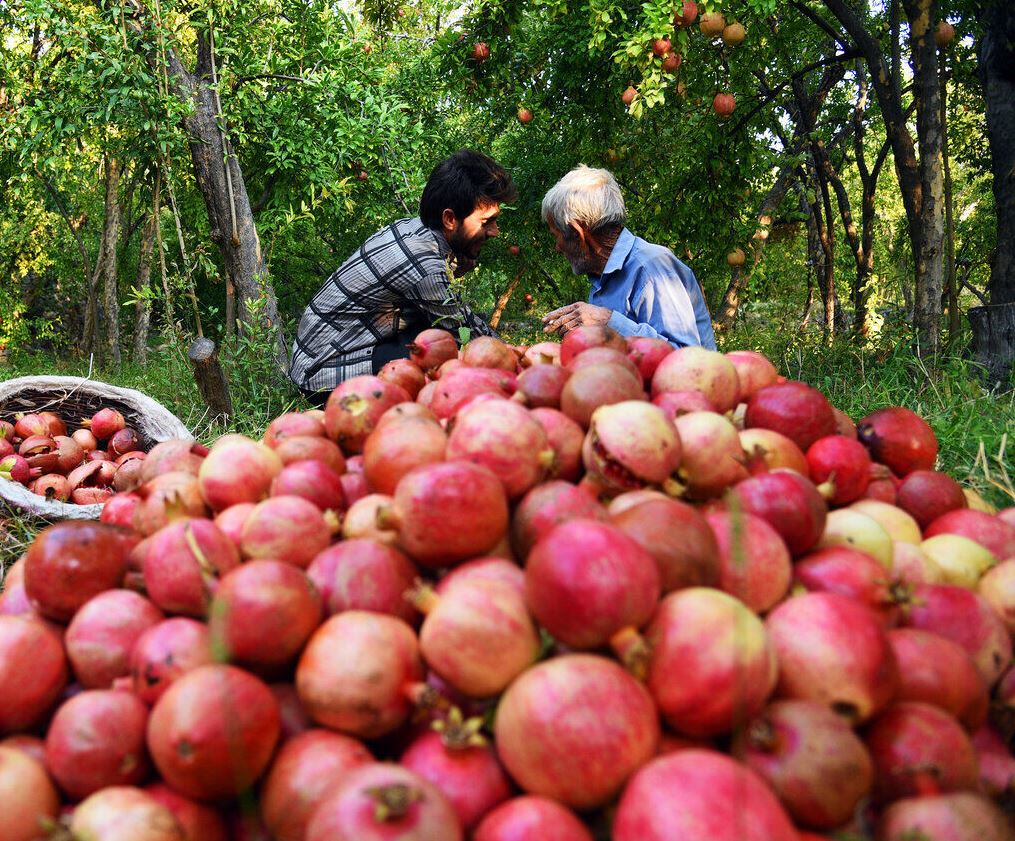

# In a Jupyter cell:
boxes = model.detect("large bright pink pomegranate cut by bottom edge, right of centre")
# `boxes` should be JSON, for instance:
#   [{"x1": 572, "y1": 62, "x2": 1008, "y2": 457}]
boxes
[{"x1": 613, "y1": 750, "x2": 799, "y2": 841}]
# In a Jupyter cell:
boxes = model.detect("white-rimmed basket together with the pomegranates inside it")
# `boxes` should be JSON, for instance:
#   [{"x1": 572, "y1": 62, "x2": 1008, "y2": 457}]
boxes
[{"x1": 0, "y1": 376, "x2": 192, "y2": 520}]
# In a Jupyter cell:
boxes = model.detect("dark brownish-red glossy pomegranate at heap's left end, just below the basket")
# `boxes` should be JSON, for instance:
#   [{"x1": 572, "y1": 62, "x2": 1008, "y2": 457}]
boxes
[{"x1": 24, "y1": 520, "x2": 137, "y2": 622}]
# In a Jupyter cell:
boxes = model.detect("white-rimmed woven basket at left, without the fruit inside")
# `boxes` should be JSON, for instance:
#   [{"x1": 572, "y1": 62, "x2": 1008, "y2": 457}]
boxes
[{"x1": 0, "y1": 376, "x2": 194, "y2": 521}]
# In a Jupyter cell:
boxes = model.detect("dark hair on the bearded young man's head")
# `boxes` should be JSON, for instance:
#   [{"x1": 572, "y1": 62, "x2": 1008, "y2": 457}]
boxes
[{"x1": 419, "y1": 149, "x2": 518, "y2": 230}]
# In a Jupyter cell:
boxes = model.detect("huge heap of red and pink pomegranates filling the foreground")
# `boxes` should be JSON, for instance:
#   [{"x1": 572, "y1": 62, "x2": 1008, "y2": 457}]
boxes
[{"x1": 0, "y1": 327, "x2": 1015, "y2": 841}]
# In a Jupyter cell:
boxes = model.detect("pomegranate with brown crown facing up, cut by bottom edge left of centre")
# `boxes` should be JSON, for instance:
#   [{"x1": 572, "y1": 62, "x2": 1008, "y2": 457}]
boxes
[{"x1": 306, "y1": 762, "x2": 464, "y2": 841}]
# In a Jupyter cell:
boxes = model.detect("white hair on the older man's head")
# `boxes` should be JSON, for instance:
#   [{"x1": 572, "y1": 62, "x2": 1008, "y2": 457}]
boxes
[{"x1": 542, "y1": 163, "x2": 626, "y2": 237}]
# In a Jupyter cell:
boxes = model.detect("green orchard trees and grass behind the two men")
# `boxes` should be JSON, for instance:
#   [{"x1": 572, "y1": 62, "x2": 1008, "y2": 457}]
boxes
[{"x1": 0, "y1": 0, "x2": 1015, "y2": 551}]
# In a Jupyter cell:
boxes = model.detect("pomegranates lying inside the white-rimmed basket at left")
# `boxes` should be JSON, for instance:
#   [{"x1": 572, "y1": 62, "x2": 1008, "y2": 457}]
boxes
[{"x1": 0, "y1": 407, "x2": 156, "y2": 505}]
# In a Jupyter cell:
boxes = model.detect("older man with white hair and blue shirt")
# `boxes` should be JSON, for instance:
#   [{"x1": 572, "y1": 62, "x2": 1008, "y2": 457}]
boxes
[{"x1": 543, "y1": 164, "x2": 716, "y2": 350}]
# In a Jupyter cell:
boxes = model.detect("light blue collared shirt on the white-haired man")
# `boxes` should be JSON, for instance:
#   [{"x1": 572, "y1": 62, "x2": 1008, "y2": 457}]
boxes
[{"x1": 589, "y1": 228, "x2": 716, "y2": 350}]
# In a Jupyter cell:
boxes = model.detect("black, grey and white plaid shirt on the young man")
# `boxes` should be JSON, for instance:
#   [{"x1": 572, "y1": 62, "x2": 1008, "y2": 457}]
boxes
[{"x1": 289, "y1": 217, "x2": 496, "y2": 392}]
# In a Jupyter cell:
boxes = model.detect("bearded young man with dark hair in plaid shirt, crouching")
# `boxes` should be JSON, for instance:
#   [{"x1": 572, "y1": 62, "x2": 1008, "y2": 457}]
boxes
[{"x1": 289, "y1": 149, "x2": 517, "y2": 406}]
